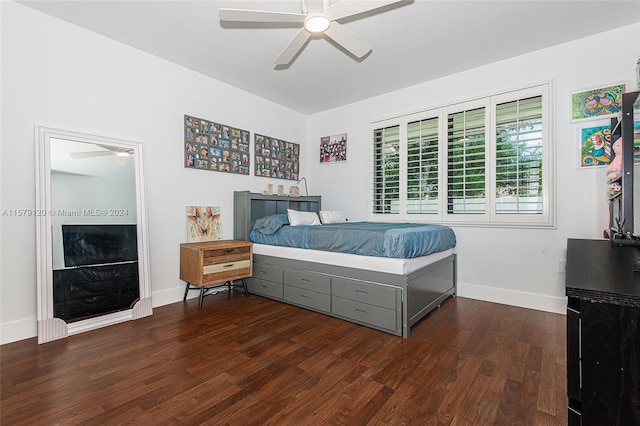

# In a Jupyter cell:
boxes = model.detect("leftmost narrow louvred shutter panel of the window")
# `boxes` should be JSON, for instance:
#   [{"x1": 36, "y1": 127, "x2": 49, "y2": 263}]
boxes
[{"x1": 372, "y1": 125, "x2": 400, "y2": 214}]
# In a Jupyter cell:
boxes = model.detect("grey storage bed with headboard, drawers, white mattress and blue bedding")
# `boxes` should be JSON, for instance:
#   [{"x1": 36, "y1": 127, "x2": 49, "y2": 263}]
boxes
[{"x1": 234, "y1": 191, "x2": 457, "y2": 338}]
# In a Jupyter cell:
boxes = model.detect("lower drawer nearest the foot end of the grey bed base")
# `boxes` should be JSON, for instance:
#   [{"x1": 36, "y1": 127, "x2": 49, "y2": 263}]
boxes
[{"x1": 331, "y1": 297, "x2": 402, "y2": 334}]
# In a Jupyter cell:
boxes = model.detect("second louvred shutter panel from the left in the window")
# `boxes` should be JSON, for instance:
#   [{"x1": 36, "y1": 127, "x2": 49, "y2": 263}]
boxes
[{"x1": 407, "y1": 117, "x2": 439, "y2": 214}]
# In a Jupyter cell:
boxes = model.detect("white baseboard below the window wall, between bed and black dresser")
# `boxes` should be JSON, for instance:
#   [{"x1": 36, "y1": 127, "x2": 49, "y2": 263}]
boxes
[{"x1": 457, "y1": 282, "x2": 567, "y2": 314}]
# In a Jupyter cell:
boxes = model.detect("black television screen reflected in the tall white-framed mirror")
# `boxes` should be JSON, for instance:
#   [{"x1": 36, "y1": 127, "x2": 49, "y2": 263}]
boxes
[{"x1": 62, "y1": 225, "x2": 138, "y2": 267}]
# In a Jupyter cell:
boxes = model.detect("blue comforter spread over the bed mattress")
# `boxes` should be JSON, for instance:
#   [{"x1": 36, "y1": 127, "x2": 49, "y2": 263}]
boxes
[{"x1": 249, "y1": 218, "x2": 456, "y2": 259}]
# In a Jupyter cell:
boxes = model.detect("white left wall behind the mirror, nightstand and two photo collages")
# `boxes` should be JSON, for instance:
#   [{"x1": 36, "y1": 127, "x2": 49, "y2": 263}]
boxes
[{"x1": 0, "y1": 1, "x2": 307, "y2": 343}]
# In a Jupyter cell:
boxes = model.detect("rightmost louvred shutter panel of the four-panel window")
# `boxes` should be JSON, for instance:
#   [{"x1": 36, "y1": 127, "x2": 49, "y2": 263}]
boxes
[{"x1": 495, "y1": 96, "x2": 543, "y2": 214}]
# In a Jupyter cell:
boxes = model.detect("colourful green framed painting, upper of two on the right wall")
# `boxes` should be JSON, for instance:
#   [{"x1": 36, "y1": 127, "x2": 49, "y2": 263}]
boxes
[{"x1": 571, "y1": 83, "x2": 627, "y2": 120}]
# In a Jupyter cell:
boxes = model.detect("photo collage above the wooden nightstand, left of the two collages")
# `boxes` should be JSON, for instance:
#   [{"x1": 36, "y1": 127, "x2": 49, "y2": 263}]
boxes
[{"x1": 184, "y1": 115, "x2": 251, "y2": 175}]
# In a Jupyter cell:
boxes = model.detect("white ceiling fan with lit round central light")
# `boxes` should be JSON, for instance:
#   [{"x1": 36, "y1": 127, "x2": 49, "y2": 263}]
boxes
[{"x1": 220, "y1": 0, "x2": 403, "y2": 65}]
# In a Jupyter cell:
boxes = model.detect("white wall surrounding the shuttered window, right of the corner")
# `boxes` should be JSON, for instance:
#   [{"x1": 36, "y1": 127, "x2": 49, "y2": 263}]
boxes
[{"x1": 306, "y1": 24, "x2": 640, "y2": 312}]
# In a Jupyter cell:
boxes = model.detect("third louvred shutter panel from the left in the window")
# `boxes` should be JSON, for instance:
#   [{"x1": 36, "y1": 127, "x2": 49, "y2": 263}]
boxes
[{"x1": 447, "y1": 108, "x2": 486, "y2": 214}]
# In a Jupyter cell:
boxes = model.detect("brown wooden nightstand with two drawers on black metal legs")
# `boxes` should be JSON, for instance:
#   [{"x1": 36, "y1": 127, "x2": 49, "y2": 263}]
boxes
[{"x1": 180, "y1": 240, "x2": 253, "y2": 309}]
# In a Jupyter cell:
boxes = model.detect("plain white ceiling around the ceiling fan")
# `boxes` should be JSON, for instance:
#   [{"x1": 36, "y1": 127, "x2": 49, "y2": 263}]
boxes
[{"x1": 20, "y1": 0, "x2": 640, "y2": 114}]
